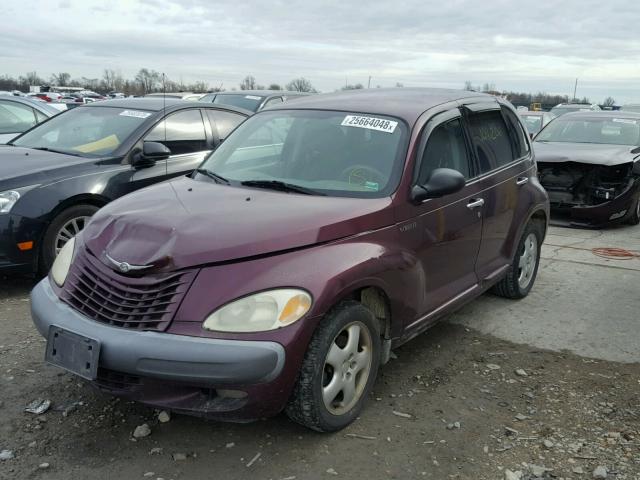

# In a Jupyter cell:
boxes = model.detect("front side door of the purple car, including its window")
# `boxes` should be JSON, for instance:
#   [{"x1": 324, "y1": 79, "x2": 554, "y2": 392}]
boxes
[{"x1": 406, "y1": 108, "x2": 482, "y2": 335}]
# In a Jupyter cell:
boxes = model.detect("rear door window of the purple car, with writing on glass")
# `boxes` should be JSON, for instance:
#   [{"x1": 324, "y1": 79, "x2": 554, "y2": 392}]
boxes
[{"x1": 468, "y1": 110, "x2": 515, "y2": 174}]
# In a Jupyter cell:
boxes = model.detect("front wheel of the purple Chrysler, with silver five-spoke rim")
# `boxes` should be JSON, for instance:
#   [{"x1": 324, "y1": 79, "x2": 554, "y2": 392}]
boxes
[{"x1": 285, "y1": 301, "x2": 381, "y2": 432}]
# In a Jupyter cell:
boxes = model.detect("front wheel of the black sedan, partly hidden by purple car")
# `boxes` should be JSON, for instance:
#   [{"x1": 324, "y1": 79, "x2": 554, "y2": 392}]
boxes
[{"x1": 38, "y1": 204, "x2": 98, "y2": 275}]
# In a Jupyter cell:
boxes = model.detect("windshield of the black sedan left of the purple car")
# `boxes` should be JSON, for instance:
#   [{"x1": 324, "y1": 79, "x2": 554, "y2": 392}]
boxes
[{"x1": 12, "y1": 107, "x2": 152, "y2": 157}]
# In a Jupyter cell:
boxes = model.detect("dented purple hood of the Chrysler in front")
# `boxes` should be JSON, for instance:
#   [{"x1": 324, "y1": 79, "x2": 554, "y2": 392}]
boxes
[{"x1": 83, "y1": 178, "x2": 393, "y2": 271}]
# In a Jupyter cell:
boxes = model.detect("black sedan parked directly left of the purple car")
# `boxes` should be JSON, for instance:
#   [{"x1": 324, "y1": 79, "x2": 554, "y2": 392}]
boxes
[{"x1": 0, "y1": 98, "x2": 251, "y2": 273}]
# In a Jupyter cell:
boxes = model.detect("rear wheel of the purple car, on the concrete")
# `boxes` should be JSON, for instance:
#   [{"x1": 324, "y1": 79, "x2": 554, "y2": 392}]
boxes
[{"x1": 492, "y1": 222, "x2": 543, "y2": 299}]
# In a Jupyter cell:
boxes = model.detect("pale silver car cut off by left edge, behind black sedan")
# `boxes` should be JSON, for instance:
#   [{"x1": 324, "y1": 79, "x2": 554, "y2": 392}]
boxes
[{"x1": 0, "y1": 95, "x2": 60, "y2": 144}]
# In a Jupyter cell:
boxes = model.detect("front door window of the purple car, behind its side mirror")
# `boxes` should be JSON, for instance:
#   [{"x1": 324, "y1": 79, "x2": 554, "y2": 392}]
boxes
[{"x1": 418, "y1": 118, "x2": 471, "y2": 185}]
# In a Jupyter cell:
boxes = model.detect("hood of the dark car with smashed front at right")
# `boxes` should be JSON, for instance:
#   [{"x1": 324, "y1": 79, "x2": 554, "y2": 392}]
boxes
[{"x1": 533, "y1": 142, "x2": 638, "y2": 166}]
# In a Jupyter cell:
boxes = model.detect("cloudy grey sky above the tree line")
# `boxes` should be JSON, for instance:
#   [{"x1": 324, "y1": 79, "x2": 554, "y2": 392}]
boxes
[{"x1": 0, "y1": 0, "x2": 640, "y2": 104}]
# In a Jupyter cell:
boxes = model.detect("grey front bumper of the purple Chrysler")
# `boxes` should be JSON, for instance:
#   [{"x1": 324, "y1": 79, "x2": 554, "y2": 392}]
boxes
[{"x1": 31, "y1": 278, "x2": 285, "y2": 386}]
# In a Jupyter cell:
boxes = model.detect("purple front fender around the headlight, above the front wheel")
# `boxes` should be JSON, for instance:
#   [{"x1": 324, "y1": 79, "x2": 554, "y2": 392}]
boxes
[{"x1": 174, "y1": 225, "x2": 424, "y2": 339}]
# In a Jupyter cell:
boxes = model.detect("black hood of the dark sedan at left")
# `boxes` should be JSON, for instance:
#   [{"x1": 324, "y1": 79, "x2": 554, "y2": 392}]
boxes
[{"x1": 0, "y1": 145, "x2": 91, "y2": 190}]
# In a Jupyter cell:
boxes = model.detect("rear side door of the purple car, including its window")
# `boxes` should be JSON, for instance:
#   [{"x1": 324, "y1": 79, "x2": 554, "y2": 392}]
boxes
[{"x1": 465, "y1": 102, "x2": 533, "y2": 282}]
